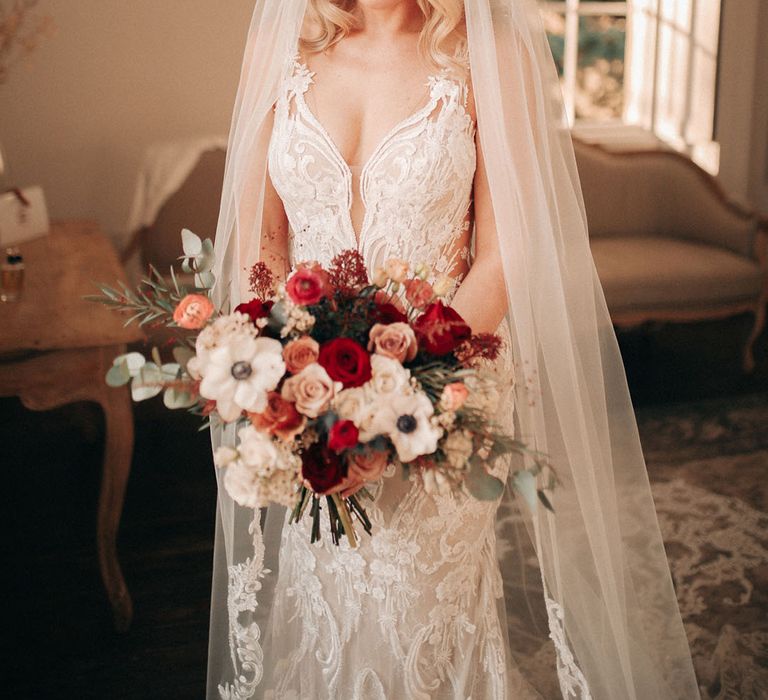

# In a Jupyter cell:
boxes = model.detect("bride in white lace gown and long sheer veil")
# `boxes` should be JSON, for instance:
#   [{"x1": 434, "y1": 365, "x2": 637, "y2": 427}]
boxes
[{"x1": 208, "y1": 0, "x2": 698, "y2": 700}]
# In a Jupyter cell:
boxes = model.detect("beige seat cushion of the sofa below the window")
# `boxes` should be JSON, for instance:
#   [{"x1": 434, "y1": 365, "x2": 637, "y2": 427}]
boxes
[{"x1": 590, "y1": 236, "x2": 762, "y2": 313}]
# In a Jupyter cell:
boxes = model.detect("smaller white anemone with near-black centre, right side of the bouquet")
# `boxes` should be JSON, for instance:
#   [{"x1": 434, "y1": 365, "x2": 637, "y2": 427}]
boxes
[{"x1": 379, "y1": 392, "x2": 443, "y2": 462}]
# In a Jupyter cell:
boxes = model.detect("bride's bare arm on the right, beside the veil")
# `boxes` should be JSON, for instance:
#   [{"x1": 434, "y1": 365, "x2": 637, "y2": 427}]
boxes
[{"x1": 451, "y1": 137, "x2": 507, "y2": 333}]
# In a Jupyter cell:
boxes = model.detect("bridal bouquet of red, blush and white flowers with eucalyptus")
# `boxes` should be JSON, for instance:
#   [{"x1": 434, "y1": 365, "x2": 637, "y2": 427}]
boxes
[{"x1": 92, "y1": 230, "x2": 554, "y2": 547}]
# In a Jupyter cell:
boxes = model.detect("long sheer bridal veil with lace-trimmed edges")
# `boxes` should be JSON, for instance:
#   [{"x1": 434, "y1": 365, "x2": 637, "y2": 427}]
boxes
[{"x1": 208, "y1": 0, "x2": 699, "y2": 700}]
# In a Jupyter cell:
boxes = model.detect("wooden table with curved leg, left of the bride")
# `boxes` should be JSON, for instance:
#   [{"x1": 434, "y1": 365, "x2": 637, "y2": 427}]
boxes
[{"x1": 0, "y1": 221, "x2": 143, "y2": 631}]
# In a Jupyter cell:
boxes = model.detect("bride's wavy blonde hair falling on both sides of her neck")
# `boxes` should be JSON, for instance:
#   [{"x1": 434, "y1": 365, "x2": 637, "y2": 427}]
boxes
[{"x1": 301, "y1": 0, "x2": 467, "y2": 70}]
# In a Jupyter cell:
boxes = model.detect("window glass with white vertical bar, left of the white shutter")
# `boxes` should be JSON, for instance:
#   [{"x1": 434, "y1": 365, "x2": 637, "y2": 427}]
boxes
[{"x1": 542, "y1": 0, "x2": 628, "y2": 123}]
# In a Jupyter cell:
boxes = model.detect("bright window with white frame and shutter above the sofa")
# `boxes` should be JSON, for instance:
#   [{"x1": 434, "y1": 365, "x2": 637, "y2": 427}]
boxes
[{"x1": 541, "y1": 0, "x2": 722, "y2": 173}]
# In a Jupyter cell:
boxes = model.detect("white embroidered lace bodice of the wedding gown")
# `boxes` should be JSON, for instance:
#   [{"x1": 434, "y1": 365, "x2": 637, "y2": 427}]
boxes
[{"x1": 269, "y1": 61, "x2": 476, "y2": 275}]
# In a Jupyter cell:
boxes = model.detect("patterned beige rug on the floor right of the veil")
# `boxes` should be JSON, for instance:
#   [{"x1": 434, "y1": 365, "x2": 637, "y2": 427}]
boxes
[{"x1": 638, "y1": 395, "x2": 768, "y2": 700}]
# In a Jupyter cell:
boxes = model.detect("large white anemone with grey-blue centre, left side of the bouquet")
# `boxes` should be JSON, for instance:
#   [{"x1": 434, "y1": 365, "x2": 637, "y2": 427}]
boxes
[{"x1": 195, "y1": 329, "x2": 285, "y2": 422}]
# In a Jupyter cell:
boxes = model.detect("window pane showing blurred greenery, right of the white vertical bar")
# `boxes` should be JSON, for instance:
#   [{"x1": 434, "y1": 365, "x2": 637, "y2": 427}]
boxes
[{"x1": 575, "y1": 15, "x2": 627, "y2": 121}]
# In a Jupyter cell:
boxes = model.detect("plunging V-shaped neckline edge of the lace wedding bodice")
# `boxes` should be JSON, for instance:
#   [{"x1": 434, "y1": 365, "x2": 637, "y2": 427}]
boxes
[{"x1": 294, "y1": 60, "x2": 441, "y2": 251}]
